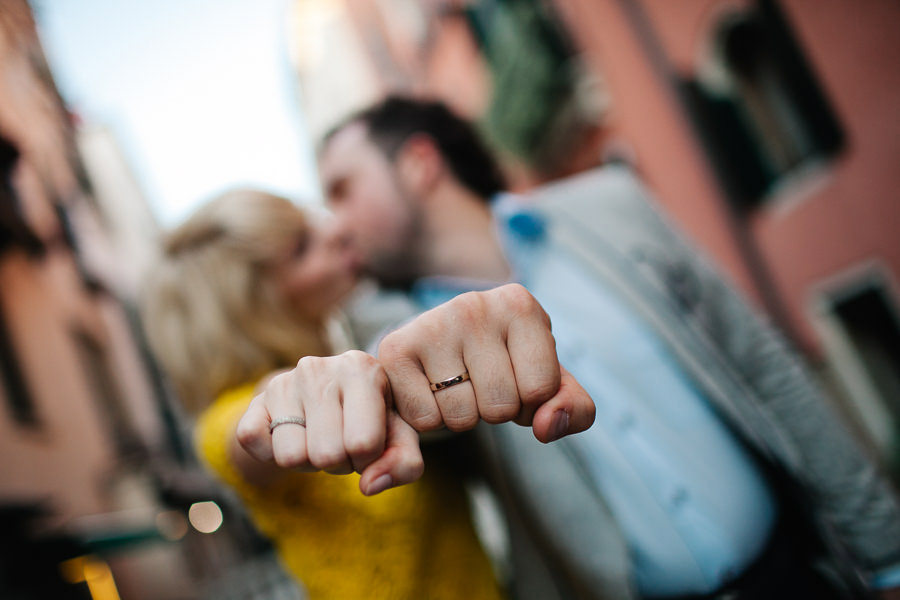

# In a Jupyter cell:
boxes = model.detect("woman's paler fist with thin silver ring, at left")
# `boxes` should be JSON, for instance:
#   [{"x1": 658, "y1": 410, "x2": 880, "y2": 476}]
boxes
[{"x1": 236, "y1": 351, "x2": 424, "y2": 495}]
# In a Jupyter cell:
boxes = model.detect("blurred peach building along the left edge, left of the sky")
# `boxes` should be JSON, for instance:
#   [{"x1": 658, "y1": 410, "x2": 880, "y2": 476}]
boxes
[{"x1": 0, "y1": 2, "x2": 142, "y2": 519}]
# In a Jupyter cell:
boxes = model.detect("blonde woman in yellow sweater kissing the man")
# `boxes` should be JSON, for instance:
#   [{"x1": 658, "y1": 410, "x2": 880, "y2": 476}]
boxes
[{"x1": 144, "y1": 190, "x2": 500, "y2": 599}]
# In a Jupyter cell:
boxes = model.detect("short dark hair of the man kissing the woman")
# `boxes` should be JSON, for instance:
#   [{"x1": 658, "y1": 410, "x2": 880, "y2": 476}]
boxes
[{"x1": 322, "y1": 96, "x2": 506, "y2": 200}]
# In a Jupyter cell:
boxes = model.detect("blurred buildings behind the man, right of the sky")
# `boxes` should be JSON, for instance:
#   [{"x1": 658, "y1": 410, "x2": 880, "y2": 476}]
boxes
[{"x1": 294, "y1": 0, "x2": 900, "y2": 460}]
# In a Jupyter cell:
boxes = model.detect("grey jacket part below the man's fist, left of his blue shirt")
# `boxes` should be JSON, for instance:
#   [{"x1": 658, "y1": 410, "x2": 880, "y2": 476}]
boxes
[{"x1": 476, "y1": 423, "x2": 635, "y2": 600}]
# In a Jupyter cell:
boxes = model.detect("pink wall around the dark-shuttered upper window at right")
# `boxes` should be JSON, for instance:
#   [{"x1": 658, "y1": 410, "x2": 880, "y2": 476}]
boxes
[{"x1": 556, "y1": 0, "x2": 900, "y2": 354}]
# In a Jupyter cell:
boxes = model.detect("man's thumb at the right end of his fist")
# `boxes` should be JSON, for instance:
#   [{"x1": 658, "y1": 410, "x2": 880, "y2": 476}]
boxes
[{"x1": 532, "y1": 366, "x2": 595, "y2": 444}]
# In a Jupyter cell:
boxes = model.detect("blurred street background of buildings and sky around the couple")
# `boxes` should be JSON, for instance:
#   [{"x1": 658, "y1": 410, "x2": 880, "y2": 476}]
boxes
[{"x1": 0, "y1": 0, "x2": 900, "y2": 599}]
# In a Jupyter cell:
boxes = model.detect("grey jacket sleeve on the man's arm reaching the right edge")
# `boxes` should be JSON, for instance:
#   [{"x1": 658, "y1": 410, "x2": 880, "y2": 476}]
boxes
[{"x1": 588, "y1": 166, "x2": 900, "y2": 573}]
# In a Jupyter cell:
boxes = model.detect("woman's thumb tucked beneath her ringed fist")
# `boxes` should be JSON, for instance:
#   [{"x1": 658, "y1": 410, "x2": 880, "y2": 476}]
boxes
[{"x1": 359, "y1": 410, "x2": 425, "y2": 496}]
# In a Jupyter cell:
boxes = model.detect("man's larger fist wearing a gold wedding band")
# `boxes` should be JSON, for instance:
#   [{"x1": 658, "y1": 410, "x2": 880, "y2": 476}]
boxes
[{"x1": 378, "y1": 284, "x2": 594, "y2": 442}]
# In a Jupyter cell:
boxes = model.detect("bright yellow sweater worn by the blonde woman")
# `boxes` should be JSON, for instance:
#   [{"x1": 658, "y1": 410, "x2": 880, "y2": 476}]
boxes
[{"x1": 196, "y1": 385, "x2": 502, "y2": 600}]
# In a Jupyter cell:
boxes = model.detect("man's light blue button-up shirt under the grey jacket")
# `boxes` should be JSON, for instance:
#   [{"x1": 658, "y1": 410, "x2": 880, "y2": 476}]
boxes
[{"x1": 413, "y1": 197, "x2": 777, "y2": 596}]
